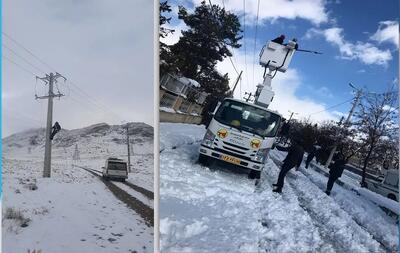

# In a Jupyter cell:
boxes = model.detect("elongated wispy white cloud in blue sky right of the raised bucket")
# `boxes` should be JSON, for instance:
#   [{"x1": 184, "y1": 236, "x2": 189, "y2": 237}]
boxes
[{"x1": 305, "y1": 27, "x2": 392, "y2": 65}]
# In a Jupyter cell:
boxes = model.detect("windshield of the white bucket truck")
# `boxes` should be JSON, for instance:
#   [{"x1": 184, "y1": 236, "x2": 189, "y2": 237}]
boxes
[{"x1": 214, "y1": 100, "x2": 281, "y2": 137}]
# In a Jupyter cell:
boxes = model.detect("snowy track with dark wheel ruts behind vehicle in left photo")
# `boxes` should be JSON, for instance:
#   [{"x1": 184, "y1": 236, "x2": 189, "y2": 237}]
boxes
[{"x1": 75, "y1": 165, "x2": 154, "y2": 227}]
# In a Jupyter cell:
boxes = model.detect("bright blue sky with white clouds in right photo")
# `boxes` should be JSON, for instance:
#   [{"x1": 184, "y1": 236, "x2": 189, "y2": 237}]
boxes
[{"x1": 161, "y1": 0, "x2": 399, "y2": 121}]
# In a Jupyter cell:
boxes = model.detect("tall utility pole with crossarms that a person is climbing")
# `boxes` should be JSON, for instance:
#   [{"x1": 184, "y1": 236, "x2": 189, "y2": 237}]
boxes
[{"x1": 36, "y1": 72, "x2": 67, "y2": 177}]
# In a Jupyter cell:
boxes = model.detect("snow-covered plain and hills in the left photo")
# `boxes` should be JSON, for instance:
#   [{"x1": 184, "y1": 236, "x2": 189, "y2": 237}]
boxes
[{"x1": 2, "y1": 123, "x2": 154, "y2": 253}]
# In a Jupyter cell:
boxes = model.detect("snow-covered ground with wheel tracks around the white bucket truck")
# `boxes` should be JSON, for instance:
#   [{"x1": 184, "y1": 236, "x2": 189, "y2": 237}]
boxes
[{"x1": 160, "y1": 124, "x2": 398, "y2": 252}]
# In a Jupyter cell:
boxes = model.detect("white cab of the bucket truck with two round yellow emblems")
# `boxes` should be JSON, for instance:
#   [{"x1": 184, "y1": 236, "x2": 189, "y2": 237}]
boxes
[{"x1": 199, "y1": 98, "x2": 282, "y2": 178}]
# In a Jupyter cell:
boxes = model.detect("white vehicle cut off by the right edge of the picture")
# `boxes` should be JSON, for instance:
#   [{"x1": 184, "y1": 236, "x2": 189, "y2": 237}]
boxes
[{"x1": 367, "y1": 170, "x2": 399, "y2": 201}]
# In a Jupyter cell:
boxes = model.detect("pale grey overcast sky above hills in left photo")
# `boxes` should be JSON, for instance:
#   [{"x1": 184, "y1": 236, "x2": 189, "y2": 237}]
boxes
[{"x1": 2, "y1": 0, "x2": 154, "y2": 137}]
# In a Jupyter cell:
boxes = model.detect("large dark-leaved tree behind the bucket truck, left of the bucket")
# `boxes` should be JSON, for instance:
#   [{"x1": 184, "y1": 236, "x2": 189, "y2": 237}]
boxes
[{"x1": 167, "y1": 1, "x2": 242, "y2": 121}]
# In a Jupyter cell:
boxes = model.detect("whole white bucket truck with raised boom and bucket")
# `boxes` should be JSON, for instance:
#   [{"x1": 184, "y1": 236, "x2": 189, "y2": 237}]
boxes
[{"x1": 199, "y1": 40, "x2": 297, "y2": 178}]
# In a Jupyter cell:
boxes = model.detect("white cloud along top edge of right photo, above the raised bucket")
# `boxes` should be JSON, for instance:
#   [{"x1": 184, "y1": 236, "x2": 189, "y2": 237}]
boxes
[{"x1": 193, "y1": 0, "x2": 328, "y2": 25}]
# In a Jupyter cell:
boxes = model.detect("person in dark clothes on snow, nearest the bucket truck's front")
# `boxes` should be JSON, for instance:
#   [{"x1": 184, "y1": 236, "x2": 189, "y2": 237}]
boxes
[{"x1": 273, "y1": 138, "x2": 304, "y2": 193}]
